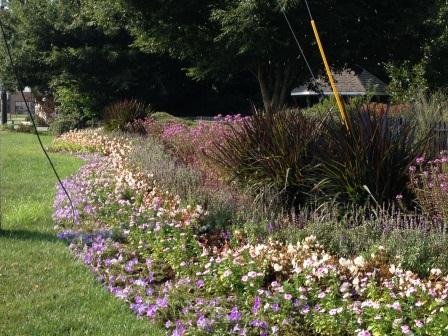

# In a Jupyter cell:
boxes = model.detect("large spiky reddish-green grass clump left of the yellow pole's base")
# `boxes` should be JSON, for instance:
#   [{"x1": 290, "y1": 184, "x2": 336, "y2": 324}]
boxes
[{"x1": 211, "y1": 110, "x2": 322, "y2": 206}]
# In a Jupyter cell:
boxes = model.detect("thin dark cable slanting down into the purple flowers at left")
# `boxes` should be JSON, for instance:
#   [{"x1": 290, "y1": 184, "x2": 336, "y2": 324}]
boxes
[{"x1": 0, "y1": 16, "x2": 76, "y2": 224}]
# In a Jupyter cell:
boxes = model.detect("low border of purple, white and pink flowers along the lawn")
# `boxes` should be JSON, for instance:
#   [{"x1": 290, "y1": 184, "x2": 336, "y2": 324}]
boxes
[{"x1": 55, "y1": 132, "x2": 448, "y2": 336}]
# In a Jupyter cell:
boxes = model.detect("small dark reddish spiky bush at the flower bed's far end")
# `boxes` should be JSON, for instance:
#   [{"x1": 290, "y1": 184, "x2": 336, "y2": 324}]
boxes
[{"x1": 104, "y1": 100, "x2": 151, "y2": 131}]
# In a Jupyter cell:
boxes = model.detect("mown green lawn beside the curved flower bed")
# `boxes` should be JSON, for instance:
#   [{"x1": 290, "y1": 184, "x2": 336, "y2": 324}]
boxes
[{"x1": 0, "y1": 131, "x2": 161, "y2": 336}]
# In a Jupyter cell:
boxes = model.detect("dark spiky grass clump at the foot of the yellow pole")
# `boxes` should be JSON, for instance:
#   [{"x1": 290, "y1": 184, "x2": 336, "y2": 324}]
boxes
[{"x1": 318, "y1": 107, "x2": 428, "y2": 204}]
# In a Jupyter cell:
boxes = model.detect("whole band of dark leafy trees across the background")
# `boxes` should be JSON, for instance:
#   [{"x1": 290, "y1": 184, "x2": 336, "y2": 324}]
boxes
[{"x1": 0, "y1": 0, "x2": 447, "y2": 117}]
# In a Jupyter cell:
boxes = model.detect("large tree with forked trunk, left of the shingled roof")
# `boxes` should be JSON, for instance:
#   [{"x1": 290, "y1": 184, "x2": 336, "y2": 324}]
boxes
[{"x1": 116, "y1": 0, "x2": 433, "y2": 110}]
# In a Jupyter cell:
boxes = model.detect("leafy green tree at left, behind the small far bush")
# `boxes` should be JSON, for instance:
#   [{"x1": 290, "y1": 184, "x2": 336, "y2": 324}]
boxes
[{"x1": 0, "y1": 0, "x2": 210, "y2": 112}]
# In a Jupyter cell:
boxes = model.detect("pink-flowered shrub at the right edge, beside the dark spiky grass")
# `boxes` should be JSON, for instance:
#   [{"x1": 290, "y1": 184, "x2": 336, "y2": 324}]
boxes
[{"x1": 409, "y1": 152, "x2": 448, "y2": 227}]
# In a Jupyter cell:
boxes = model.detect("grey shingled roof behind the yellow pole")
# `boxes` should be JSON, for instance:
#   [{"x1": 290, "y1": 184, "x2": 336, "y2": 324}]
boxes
[{"x1": 291, "y1": 69, "x2": 388, "y2": 96}]
